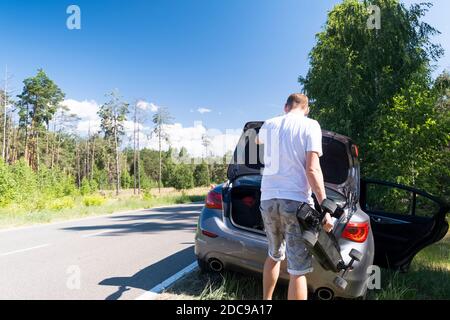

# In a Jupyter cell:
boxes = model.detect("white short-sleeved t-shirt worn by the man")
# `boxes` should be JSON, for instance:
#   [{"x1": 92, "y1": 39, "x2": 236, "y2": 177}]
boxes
[{"x1": 258, "y1": 112, "x2": 322, "y2": 205}]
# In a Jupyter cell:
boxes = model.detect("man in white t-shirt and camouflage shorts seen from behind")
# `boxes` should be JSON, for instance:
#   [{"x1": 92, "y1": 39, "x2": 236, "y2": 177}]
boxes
[{"x1": 257, "y1": 93, "x2": 333, "y2": 300}]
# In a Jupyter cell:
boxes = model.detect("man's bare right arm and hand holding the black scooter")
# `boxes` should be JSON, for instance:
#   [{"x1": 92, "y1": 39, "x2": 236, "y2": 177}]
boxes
[{"x1": 306, "y1": 152, "x2": 333, "y2": 232}]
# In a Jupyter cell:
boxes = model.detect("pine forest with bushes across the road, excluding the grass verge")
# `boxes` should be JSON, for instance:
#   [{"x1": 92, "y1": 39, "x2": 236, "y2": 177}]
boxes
[{"x1": 0, "y1": 69, "x2": 226, "y2": 209}]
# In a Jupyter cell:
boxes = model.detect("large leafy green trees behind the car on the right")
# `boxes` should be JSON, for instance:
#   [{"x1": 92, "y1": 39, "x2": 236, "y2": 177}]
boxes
[{"x1": 299, "y1": 0, "x2": 450, "y2": 201}]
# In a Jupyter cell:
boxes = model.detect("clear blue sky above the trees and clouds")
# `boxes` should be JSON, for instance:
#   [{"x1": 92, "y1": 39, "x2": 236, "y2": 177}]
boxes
[{"x1": 0, "y1": 0, "x2": 450, "y2": 154}]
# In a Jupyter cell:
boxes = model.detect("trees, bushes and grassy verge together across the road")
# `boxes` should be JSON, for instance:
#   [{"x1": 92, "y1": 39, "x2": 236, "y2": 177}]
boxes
[{"x1": 0, "y1": 69, "x2": 226, "y2": 227}]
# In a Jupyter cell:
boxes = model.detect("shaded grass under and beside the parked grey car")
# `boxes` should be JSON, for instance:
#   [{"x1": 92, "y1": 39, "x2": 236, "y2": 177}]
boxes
[{"x1": 160, "y1": 233, "x2": 450, "y2": 300}]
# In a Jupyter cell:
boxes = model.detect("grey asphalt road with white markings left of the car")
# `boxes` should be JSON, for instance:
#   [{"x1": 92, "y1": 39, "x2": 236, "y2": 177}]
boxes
[{"x1": 0, "y1": 204, "x2": 202, "y2": 300}]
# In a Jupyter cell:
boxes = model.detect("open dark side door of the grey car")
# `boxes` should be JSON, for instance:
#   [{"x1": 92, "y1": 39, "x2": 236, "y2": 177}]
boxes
[{"x1": 360, "y1": 179, "x2": 449, "y2": 271}]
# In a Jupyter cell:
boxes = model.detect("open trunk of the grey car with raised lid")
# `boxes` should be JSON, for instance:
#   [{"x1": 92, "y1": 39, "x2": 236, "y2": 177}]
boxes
[{"x1": 227, "y1": 122, "x2": 359, "y2": 232}]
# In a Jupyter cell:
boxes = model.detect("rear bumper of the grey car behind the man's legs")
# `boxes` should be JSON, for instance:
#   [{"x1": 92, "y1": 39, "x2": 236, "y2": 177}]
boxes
[{"x1": 195, "y1": 209, "x2": 373, "y2": 299}]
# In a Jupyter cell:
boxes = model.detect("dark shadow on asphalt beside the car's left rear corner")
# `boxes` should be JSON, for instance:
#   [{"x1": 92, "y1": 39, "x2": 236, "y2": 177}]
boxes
[{"x1": 99, "y1": 246, "x2": 195, "y2": 300}]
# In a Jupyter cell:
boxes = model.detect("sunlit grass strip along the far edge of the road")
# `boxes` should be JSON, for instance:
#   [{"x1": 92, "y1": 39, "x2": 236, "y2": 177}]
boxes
[{"x1": 0, "y1": 188, "x2": 208, "y2": 229}]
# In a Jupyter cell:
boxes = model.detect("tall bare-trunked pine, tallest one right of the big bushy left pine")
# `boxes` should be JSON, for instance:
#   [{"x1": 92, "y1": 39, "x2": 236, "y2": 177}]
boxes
[{"x1": 98, "y1": 90, "x2": 128, "y2": 195}]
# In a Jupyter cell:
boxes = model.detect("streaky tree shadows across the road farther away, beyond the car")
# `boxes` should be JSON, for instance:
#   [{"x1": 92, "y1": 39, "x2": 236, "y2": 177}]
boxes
[{"x1": 62, "y1": 205, "x2": 202, "y2": 237}]
